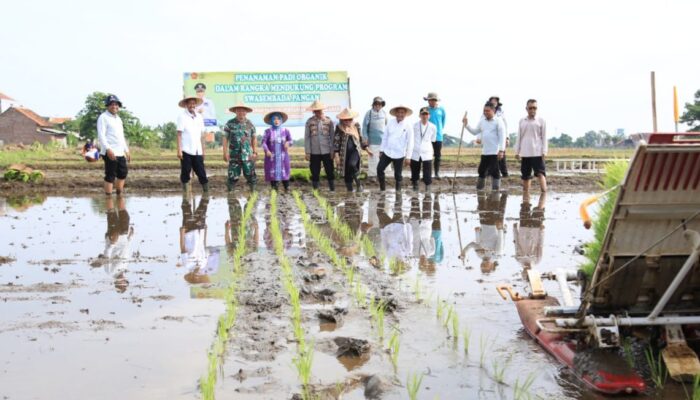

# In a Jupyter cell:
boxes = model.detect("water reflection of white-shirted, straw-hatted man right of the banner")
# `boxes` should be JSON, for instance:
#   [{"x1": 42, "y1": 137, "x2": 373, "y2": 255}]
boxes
[{"x1": 377, "y1": 194, "x2": 413, "y2": 260}]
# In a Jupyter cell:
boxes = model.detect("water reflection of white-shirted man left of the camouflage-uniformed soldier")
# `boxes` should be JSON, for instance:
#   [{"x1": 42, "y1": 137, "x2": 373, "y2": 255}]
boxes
[{"x1": 180, "y1": 195, "x2": 219, "y2": 283}]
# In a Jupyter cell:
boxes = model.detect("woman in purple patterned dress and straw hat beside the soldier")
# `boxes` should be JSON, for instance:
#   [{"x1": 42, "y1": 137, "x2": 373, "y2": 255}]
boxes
[{"x1": 263, "y1": 111, "x2": 292, "y2": 191}]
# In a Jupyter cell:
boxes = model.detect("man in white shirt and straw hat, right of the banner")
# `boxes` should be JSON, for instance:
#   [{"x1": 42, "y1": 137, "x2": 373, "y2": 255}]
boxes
[{"x1": 377, "y1": 105, "x2": 413, "y2": 192}]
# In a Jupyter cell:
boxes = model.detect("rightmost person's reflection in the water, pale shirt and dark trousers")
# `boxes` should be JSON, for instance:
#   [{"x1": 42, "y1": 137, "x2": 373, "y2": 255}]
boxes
[{"x1": 513, "y1": 192, "x2": 547, "y2": 268}]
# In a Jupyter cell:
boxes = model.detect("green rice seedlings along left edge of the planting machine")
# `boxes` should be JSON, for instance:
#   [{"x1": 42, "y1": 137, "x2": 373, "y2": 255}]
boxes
[{"x1": 581, "y1": 160, "x2": 629, "y2": 277}]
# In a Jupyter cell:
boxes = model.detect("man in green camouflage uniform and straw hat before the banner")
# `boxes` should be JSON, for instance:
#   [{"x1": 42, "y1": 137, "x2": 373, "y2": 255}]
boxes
[{"x1": 223, "y1": 103, "x2": 258, "y2": 192}]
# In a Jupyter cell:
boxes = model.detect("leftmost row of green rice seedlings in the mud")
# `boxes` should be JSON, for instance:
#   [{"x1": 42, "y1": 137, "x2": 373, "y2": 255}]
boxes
[{"x1": 199, "y1": 193, "x2": 258, "y2": 400}]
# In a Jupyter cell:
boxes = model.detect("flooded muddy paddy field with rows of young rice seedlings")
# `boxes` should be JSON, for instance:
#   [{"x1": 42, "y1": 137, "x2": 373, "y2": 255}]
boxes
[{"x1": 0, "y1": 190, "x2": 686, "y2": 399}]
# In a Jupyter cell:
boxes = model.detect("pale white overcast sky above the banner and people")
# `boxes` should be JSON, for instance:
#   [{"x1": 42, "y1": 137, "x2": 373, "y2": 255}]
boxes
[{"x1": 0, "y1": 0, "x2": 700, "y2": 137}]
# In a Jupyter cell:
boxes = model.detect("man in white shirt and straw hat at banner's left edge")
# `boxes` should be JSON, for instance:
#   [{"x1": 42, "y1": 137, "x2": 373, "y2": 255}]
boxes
[{"x1": 177, "y1": 97, "x2": 209, "y2": 193}]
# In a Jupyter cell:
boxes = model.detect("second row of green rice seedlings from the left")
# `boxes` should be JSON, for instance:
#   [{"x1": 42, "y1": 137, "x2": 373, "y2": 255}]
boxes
[{"x1": 270, "y1": 191, "x2": 314, "y2": 399}]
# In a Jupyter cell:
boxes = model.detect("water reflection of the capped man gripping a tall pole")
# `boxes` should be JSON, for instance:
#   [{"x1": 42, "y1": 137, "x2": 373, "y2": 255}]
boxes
[{"x1": 462, "y1": 192, "x2": 508, "y2": 273}]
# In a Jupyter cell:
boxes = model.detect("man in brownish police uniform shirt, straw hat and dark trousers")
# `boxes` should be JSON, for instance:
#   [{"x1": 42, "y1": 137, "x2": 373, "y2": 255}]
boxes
[{"x1": 304, "y1": 100, "x2": 335, "y2": 192}]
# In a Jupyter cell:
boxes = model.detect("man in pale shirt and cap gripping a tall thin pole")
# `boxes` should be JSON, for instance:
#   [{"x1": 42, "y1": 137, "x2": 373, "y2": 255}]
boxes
[{"x1": 462, "y1": 102, "x2": 506, "y2": 190}]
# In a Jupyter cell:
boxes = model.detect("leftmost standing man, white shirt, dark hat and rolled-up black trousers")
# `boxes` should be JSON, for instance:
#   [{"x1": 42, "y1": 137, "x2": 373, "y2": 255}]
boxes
[{"x1": 97, "y1": 94, "x2": 131, "y2": 196}]
